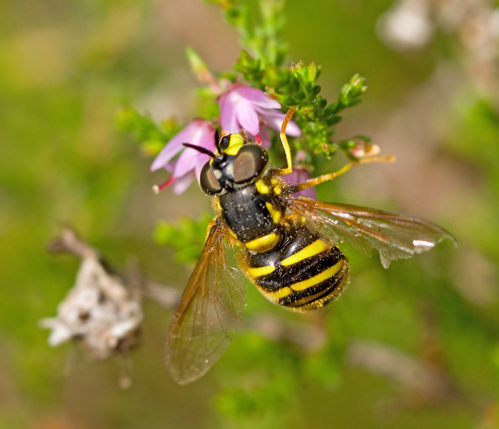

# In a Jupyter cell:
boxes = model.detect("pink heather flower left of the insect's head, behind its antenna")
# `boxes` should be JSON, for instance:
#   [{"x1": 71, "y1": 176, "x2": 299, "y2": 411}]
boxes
[{"x1": 151, "y1": 119, "x2": 215, "y2": 194}]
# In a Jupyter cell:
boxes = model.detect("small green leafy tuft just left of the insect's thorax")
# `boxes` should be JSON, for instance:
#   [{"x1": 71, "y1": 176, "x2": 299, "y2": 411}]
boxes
[{"x1": 154, "y1": 212, "x2": 213, "y2": 264}]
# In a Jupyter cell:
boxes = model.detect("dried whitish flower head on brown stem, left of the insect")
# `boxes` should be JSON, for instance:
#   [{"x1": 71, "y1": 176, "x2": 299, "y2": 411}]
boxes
[{"x1": 40, "y1": 229, "x2": 143, "y2": 359}]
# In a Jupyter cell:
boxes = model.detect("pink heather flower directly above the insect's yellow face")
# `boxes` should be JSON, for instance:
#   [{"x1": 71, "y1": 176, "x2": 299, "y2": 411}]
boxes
[{"x1": 219, "y1": 84, "x2": 301, "y2": 147}]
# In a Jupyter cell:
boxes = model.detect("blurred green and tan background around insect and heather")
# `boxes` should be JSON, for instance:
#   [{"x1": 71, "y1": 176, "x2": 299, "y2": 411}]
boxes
[{"x1": 0, "y1": 0, "x2": 499, "y2": 429}]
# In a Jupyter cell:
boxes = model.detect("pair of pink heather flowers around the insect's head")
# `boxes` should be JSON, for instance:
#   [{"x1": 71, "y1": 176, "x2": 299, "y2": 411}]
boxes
[{"x1": 151, "y1": 84, "x2": 301, "y2": 194}]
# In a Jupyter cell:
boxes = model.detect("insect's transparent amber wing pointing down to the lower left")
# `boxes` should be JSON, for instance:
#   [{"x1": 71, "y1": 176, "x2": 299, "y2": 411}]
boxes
[{"x1": 166, "y1": 222, "x2": 245, "y2": 385}]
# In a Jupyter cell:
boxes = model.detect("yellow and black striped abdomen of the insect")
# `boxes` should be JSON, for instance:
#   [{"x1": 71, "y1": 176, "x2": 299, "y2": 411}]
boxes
[{"x1": 246, "y1": 222, "x2": 348, "y2": 310}]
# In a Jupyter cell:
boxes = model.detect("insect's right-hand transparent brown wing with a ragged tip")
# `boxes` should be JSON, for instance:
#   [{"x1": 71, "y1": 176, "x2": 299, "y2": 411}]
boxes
[{"x1": 288, "y1": 196, "x2": 456, "y2": 268}]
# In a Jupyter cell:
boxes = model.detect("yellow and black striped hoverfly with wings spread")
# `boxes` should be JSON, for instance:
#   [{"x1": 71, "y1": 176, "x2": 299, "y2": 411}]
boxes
[{"x1": 166, "y1": 108, "x2": 454, "y2": 384}]
